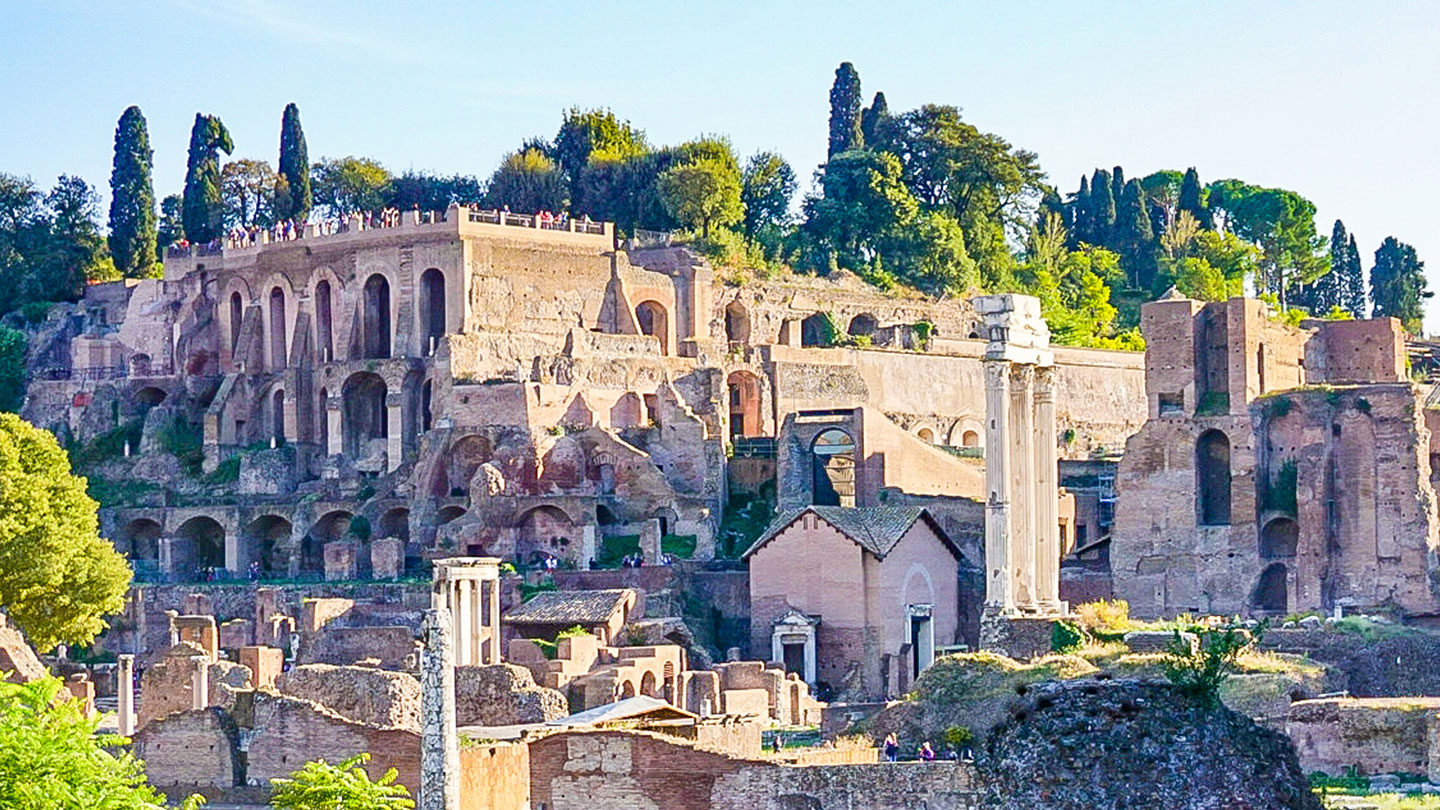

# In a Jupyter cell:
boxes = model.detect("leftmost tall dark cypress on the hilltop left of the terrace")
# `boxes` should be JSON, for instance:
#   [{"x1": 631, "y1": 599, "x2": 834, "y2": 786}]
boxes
[{"x1": 109, "y1": 107, "x2": 156, "y2": 278}]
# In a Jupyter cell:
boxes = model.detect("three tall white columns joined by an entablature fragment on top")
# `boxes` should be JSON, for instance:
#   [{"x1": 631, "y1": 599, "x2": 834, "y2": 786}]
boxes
[{"x1": 973, "y1": 295, "x2": 1066, "y2": 615}]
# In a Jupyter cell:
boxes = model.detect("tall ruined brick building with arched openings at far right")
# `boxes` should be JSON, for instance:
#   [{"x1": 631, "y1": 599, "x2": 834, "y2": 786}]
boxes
[{"x1": 1110, "y1": 295, "x2": 1440, "y2": 617}]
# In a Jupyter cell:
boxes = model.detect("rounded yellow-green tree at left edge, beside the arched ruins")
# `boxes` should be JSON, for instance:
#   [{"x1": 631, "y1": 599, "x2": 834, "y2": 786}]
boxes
[{"x1": 0, "y1": 414, "x2": 130, "y2": 651}]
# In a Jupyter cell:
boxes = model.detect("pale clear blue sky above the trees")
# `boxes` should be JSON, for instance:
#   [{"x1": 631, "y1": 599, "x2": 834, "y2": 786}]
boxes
[{"x1": 8, "y1": 0, "x2": 1440, "y2": 329}]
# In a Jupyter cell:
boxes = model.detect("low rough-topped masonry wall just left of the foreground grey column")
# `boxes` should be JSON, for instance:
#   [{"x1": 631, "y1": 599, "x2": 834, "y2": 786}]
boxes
[{"x1": 275, "y1": 664, "x2": 420, "y2": 732}]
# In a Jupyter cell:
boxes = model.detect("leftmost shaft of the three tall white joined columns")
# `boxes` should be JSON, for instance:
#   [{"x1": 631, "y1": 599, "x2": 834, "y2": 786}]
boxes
[{"x1": 985, "y1": 359, "x2": 1015, "y2": 614}]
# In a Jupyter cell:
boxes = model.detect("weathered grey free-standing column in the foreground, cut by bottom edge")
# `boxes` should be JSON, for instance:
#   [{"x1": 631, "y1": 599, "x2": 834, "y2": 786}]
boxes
[{"x1": 419, "y1": 607, "x2": 459, "y2": 810}]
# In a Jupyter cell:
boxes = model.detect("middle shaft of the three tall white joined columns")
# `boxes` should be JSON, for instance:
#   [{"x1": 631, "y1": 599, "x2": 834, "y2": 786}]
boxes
[{"x1": 1008, "y1": 363, "x2": 1035, "y2": 611}]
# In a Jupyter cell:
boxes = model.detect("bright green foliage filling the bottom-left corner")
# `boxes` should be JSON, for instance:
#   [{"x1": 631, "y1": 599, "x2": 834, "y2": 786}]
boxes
[{"x1": 0, "y1": 677, "x2": 197, "y2": 810}]
